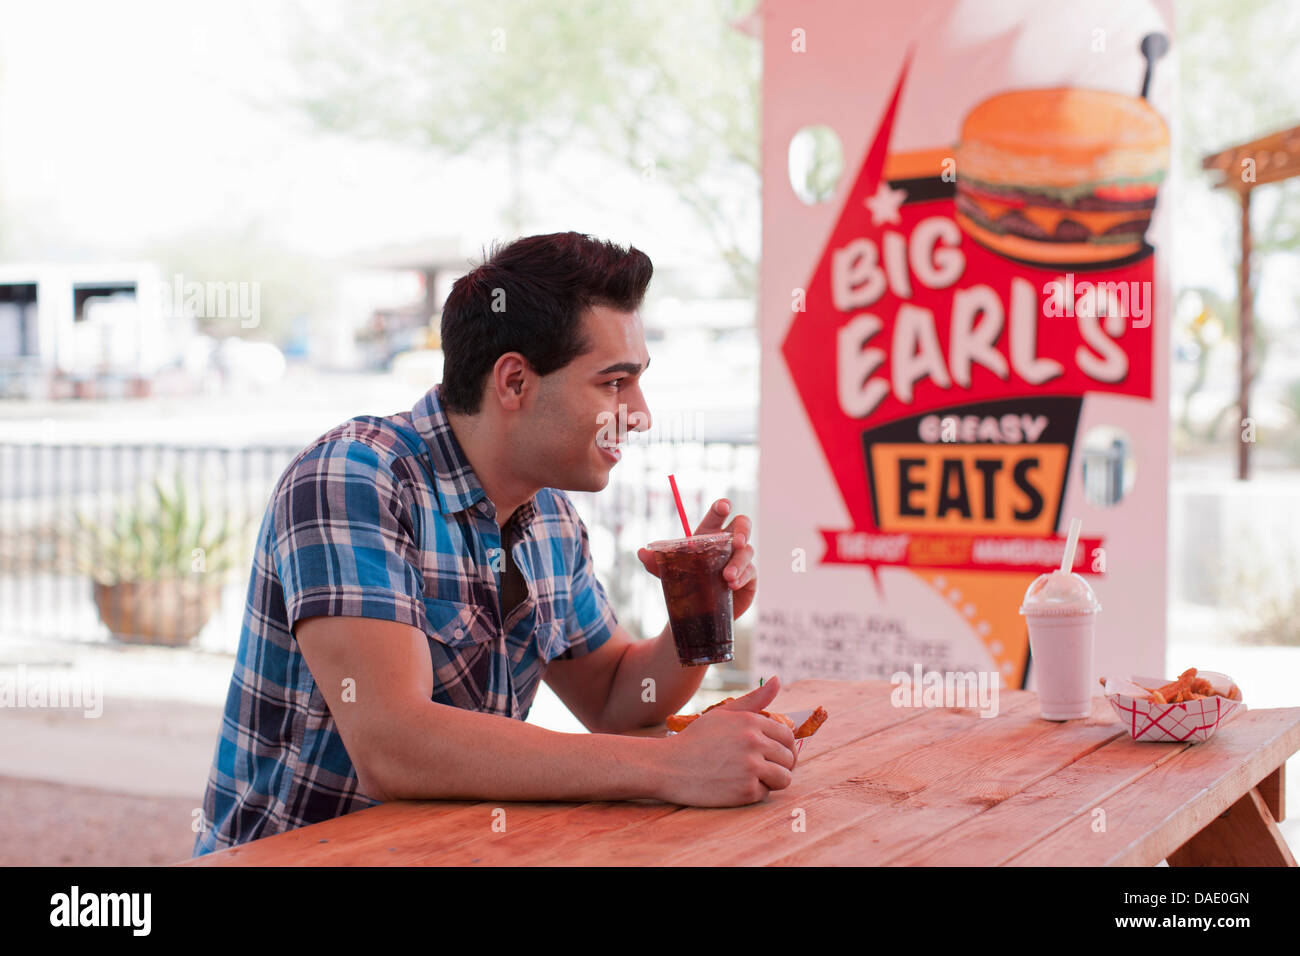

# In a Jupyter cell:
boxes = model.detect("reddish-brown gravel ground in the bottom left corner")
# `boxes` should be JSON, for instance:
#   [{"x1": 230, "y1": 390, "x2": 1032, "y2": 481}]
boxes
[{"x1": 0, "y1": 777, "x2": 195, "y2": 866}]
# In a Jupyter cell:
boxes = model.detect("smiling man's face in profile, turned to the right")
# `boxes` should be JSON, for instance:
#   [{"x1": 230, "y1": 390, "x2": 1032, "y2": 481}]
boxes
[{"x1": 517, "y1": 306, "x2": 650, "y2": 492}]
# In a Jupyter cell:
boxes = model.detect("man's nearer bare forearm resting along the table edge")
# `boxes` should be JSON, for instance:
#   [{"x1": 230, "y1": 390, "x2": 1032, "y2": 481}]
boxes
[{"x1": 372, "y1": 702, "x2": 664, "y2": 803}]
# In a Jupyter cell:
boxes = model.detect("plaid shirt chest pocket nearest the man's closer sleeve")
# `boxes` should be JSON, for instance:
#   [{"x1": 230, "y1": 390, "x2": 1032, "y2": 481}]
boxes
[{"x1": 424, "y1": 598, "x2": 499, "y2": 717}]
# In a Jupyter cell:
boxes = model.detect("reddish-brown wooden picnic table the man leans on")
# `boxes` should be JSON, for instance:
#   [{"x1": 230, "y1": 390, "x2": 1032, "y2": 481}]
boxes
[{"x1": 186, "y1": 680, "x2": 1300, "y2": 866}]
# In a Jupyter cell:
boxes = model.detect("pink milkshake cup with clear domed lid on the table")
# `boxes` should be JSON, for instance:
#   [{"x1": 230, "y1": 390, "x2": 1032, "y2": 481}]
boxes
[{"x1": 1021, "y1": 567, "x2": 1101, "y2": 721}]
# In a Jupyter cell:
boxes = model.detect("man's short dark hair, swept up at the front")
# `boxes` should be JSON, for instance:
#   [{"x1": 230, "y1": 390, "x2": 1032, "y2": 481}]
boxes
[{"x1": 438, "y1": 233, "x2": 654, "y2": 415}]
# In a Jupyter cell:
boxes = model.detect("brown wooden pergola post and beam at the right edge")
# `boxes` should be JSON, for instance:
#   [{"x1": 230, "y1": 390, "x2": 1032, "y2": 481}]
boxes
[{"x1": 1201, "y1": 126, "x2": 1300, "y2": 481}]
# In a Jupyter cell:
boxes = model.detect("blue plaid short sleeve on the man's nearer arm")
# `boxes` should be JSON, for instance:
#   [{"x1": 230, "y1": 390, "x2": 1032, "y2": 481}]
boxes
[{"x1": 273, "y1": 438, "x2": 425, "y2": 631}]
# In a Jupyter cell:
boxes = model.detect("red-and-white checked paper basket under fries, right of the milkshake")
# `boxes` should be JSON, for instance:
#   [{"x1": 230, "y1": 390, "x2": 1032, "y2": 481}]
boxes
[{"x1": 1101, "y1": 671, "x2": 1245, "y2": 744}]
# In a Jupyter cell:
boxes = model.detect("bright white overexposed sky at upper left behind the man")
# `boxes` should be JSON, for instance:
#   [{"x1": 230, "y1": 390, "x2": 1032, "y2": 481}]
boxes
[{"x1": 0, "y1": 0, "x2": 743, "y2": 283}]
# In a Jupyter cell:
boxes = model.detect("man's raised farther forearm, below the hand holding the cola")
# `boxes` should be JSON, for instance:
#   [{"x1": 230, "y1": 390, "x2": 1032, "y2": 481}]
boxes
[{"x1": 601, "y1": 627, "x2": 709, "y2": 732}]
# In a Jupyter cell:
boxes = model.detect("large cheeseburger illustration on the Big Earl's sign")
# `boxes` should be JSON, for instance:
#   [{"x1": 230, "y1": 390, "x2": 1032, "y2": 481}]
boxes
[{"x1": 957, "y1": 87, "x2": 1169, "y2": 267}]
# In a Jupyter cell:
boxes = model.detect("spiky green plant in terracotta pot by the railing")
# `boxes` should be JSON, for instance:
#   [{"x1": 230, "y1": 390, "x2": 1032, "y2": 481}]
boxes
[{"x1": 77, "y1": 475, "x2": 242, "y2": 646}]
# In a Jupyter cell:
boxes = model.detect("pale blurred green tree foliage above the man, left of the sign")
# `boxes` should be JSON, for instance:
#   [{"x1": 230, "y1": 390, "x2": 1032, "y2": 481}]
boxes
[{"x1": 281, "y1": 0, "x2": 761, "y2": 294}]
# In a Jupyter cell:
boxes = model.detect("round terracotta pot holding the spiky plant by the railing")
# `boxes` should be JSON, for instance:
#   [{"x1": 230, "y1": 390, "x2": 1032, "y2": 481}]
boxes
[{"x1": 95, "y1": 578, "x2": 221, "y2": 648}]
